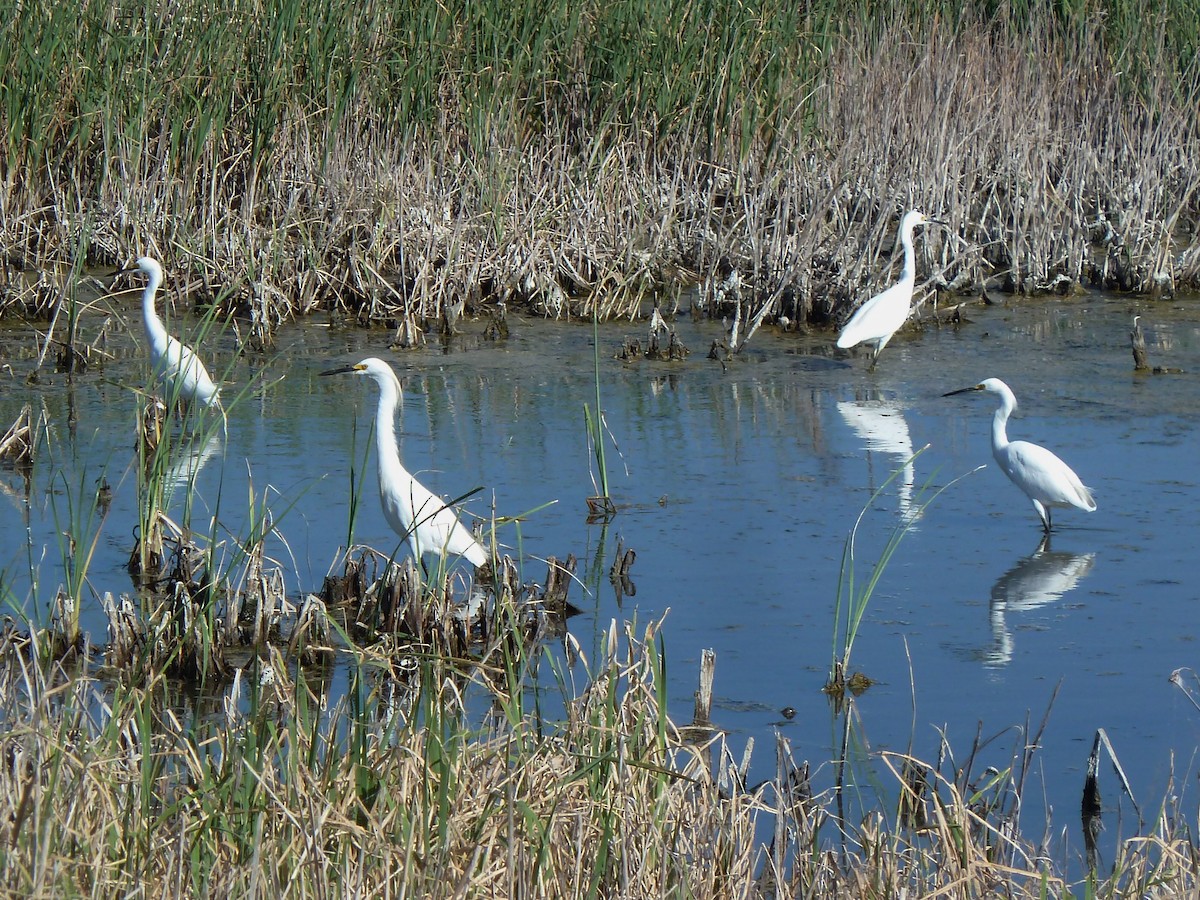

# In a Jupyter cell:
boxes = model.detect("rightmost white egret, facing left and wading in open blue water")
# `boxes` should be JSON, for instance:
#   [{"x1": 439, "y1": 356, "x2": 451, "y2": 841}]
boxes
[{"x1": 942, "y1": 378, "x2": 1096, "y2": 533}]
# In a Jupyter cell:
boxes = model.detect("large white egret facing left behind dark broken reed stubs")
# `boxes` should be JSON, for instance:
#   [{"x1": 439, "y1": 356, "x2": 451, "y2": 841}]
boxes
[{"x1": 320, "y1": 358, "x2": 487, "y2": 566}]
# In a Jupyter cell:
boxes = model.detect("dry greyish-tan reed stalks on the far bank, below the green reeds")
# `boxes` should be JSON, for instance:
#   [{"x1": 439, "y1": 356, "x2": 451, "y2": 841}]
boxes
[{"x1": 0, "y1": 12, "x2": 1200, "y2": 340}]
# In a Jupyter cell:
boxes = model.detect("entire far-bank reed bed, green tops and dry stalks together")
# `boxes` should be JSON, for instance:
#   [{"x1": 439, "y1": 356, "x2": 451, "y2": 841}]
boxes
[{"x1": 0, "y1": 0, "x2": 1200, "y2": 343}]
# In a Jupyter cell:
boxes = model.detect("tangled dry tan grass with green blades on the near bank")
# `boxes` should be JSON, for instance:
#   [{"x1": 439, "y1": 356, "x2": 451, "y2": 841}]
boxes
[{"x1": 0, "y1": 607, "x2": 1200, "y2": 899}]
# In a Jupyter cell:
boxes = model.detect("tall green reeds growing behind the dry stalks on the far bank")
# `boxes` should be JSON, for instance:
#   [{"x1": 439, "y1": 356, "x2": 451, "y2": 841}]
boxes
[{"x1": 0, "y1": 0, "x2": 1180, "y2": 172}]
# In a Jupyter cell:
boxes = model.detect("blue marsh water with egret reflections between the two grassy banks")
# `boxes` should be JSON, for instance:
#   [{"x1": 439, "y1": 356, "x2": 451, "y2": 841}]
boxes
[{"x1": 0, "y1": 294, "x2": 1200, "y2": 864}]
